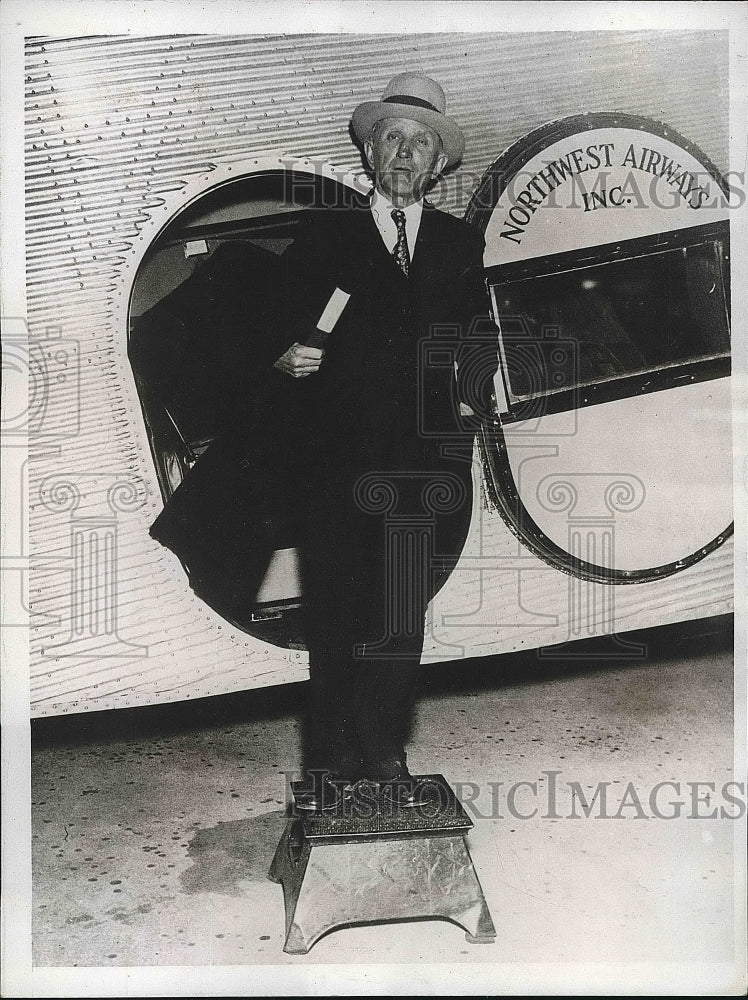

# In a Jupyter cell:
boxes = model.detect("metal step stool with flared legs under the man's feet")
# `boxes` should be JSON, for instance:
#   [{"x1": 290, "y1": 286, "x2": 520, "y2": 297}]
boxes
[{"x1": 268, "y1": 774, "x2": 496, "y2": 955}]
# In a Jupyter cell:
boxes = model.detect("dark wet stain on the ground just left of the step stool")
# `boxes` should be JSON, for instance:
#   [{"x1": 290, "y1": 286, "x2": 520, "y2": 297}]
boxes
[{"x1": 180, "y1": 809, "x2": 286, "y2": 896}]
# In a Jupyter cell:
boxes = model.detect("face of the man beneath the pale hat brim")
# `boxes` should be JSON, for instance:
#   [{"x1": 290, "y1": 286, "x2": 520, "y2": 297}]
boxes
[{"x1": 364, "y1": 118, "x2": 447, "y2": 208}]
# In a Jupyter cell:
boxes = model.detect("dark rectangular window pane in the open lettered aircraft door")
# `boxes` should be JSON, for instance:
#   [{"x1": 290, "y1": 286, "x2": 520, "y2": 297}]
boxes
[{"x1": 492, "y1": 234, "x2": 730, "y2": 404}]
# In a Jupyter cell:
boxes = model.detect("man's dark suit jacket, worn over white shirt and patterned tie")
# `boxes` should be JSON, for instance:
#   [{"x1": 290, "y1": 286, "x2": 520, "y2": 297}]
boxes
[{"x1": 268, "y1": 191, "x2": 496, "y2": 468}]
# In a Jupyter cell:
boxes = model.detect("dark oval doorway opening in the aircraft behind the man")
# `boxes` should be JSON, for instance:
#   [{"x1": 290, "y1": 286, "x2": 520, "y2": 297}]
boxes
[{"x1": 128, "y1": 169, "x2": 356, "y2": 648}]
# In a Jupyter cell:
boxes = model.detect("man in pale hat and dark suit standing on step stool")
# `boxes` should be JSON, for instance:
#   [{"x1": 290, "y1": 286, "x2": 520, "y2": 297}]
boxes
[{"x1": 266, "y1": 73, "x2": 486, "y2": 810}]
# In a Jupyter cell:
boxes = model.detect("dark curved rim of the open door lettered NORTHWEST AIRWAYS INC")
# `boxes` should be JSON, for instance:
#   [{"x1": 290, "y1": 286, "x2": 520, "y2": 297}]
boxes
[{"x1": 465, "y1": 112, "x2": 734, "y2": 584}]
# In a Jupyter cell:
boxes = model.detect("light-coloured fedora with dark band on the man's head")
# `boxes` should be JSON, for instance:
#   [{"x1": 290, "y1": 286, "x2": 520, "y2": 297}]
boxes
[{"x1": 351, "y1": 73, "x2": 465, "y2": 167}]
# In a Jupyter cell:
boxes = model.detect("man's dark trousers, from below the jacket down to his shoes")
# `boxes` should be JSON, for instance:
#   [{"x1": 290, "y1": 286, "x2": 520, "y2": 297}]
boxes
[{"x1": 300, "y1": 450, "x2": 471, "y2": 780}]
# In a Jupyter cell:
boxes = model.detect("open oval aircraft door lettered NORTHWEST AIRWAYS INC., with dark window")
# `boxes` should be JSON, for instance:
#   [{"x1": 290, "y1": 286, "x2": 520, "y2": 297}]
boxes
[{"x1": 467, "y1": 113, "x2": 732, "y2": 583}]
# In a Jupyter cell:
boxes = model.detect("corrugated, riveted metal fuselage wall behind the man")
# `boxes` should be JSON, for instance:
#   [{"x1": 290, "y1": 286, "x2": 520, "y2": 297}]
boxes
[{"x1": 19, "y1": 32, "x2": 732, "y2": 715}]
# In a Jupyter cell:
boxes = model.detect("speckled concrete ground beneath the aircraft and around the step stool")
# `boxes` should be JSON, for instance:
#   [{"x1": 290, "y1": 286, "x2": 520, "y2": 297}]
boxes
[{"x1": 32, "y1": 619, "x2": 744, "y2": 984}]
